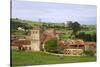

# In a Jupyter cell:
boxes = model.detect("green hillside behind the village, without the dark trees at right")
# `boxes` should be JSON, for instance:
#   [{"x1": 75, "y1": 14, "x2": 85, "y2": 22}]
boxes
[{"x1": 11, "y1": 18, "x2": 96, "y2": 40}]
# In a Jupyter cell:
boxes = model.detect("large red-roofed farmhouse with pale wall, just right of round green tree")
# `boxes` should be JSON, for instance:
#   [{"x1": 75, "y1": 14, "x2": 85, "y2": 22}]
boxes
[{"x1": 60, "y1": 39, "x2": 84, "y2": 56}]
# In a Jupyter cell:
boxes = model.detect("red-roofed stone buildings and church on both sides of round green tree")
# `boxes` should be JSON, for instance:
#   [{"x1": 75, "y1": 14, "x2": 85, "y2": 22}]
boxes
[{"x1": 11, "y1": 28, "x2": 96, "y2": 56}]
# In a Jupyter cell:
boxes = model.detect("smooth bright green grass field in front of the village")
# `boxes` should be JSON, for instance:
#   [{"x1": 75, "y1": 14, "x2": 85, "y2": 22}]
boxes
[{"x1": 12, "y1": 50, "x2": 96, "y2": 66}]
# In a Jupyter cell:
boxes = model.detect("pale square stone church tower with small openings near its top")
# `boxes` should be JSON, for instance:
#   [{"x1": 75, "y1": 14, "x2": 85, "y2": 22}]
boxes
[{"x1": 31, "y1": 29, "x2": 40, "y2": 51}]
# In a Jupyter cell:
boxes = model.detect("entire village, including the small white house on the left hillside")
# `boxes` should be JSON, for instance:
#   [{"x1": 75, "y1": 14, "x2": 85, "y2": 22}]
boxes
[{"x1": 11, "y1": 18, "x2": 96, "y2": 56}]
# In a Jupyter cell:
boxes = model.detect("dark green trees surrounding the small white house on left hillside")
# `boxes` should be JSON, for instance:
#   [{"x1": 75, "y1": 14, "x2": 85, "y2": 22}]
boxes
[{"x1": 10, "y1": 18, "x2": 32, "y2": 35}]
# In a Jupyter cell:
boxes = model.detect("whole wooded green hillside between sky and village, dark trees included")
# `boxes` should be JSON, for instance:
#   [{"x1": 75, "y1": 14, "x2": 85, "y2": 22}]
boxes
[{"x1": 10, "y1": 18, "x2": 96, "y2": 41}]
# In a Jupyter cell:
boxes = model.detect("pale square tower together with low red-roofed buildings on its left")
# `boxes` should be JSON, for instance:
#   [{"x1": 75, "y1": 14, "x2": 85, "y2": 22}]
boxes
[{"x1": 11, "y1": 28, "x2": 40, "y2": 51}]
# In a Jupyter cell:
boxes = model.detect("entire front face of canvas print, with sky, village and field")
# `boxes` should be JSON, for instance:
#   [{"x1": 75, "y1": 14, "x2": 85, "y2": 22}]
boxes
[{"x1": 10, "y1": 0, "x2": 97, "y2": 66}]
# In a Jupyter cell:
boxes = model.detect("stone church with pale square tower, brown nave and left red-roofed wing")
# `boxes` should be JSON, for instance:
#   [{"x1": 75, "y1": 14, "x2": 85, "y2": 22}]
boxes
[{"x1": 11, "y1": 28, "x2": 55, "y2": 51}]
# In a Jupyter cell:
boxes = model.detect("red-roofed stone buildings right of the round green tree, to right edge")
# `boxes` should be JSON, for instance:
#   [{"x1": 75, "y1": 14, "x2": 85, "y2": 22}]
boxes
[{"x1": 59, "y1": 39, "x2": 96, "y2": 56}]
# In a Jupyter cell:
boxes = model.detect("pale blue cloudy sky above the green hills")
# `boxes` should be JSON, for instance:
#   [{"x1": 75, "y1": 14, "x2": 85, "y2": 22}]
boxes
[{"x1": 12, "y1": 0, "x2": 97, "y2": 24}]
